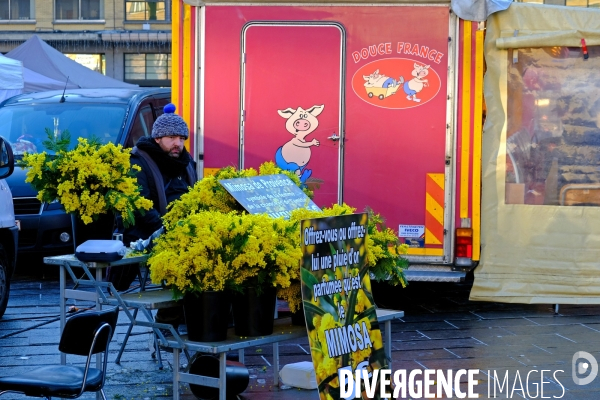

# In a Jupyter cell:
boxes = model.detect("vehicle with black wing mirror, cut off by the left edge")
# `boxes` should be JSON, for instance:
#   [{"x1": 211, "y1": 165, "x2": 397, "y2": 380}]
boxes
[{"x1": 0, "y1": 136, "x2": 18, "y2": 318}]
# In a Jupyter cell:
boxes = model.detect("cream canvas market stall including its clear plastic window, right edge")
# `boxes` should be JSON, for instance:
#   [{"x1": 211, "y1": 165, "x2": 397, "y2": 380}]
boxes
[{"x1": 471, "y1": 3, "x2": 600, "y2": 304}]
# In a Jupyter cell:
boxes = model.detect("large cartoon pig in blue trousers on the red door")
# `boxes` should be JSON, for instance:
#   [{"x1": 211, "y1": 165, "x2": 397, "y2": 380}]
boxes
[{"x1": 275, "y1": 105, "x2": 325, "y2": 183}]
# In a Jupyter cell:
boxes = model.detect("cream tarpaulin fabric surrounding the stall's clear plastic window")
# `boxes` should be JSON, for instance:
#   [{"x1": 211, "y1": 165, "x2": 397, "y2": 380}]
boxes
[{"x1": 470, "y1": 3, "x2": 600, "y2": 304}]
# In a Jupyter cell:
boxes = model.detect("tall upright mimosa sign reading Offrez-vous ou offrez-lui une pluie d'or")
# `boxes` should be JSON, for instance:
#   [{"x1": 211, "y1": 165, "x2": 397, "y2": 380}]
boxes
[{"x1": 301, "y1": 214, "x2": 387, "y2": 399}]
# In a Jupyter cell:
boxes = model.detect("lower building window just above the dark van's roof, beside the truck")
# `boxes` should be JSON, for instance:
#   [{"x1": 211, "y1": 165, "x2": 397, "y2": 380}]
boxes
[{"x1": 125, "y1": 54, "x2": 171, "y2": 86}]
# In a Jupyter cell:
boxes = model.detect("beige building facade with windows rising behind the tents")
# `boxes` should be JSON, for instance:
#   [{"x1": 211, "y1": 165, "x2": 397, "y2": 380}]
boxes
[{"x1": 0, "y1": 0, "x2": 171, "y2": 86}]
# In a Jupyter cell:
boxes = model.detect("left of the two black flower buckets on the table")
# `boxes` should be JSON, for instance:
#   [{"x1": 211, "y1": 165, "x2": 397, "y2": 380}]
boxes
[{"x1": 183, "y1": 291, "x2": 231, "y2": 342}]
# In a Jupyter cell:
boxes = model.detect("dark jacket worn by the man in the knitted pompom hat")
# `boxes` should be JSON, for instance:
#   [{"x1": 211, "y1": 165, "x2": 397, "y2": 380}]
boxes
[{"x1": 123, "y1": 137, "x2": 198, "y2": 244}]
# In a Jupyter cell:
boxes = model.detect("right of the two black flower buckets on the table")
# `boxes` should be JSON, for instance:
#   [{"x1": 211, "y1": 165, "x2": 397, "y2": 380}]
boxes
[{"x1": 231, "y1": 287, "x2": 277, "y2": 336}]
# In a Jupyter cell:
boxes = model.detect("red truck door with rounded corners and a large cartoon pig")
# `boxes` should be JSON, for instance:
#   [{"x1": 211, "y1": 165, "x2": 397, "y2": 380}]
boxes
[{"x1": 240, "y1": 22, "x2": 344, "y2": 207}]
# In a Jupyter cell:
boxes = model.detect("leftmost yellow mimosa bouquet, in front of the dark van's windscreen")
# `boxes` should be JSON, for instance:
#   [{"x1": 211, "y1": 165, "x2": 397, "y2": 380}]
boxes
[{"x1": 18, "y1": 128, "x2": 152, "y2": 226}]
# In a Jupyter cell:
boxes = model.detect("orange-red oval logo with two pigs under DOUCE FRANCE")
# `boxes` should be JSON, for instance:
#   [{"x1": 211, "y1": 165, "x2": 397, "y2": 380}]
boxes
[{"x1": 352, "y1": 58, "x2": 441, "y2": 109}]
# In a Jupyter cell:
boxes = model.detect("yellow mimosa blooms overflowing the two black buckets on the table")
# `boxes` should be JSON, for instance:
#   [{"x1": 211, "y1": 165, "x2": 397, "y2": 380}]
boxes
[{"x1": 148, "y1": 211, "x2": 302, "y2": 297}]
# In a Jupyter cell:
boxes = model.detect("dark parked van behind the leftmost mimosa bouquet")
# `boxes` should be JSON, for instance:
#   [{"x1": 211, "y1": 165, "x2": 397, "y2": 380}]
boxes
[{"x1": 0, "y1": 88, "x2": 171, "y2": 257}]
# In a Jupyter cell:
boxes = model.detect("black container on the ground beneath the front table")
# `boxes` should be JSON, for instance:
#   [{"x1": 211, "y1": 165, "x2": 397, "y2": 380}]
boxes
[{"x1": 189, "y1": 354, "x2": 250, "y2": 400}]
